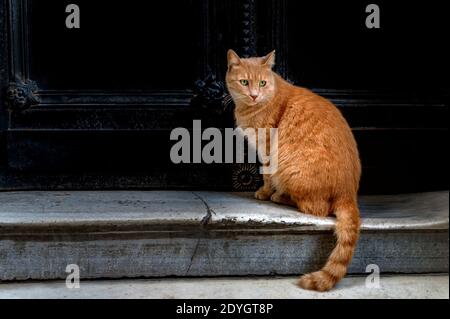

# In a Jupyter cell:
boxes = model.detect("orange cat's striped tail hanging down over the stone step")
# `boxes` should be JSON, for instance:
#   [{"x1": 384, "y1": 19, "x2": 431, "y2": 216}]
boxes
[{"x1": 298, "y1": 200, "x2": 361, "y2": 291}]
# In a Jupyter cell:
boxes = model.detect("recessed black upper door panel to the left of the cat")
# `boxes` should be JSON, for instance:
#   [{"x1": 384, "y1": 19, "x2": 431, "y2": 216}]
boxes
[{"x1": 28, "y1": 0, "x2": 205, "y2": 91}]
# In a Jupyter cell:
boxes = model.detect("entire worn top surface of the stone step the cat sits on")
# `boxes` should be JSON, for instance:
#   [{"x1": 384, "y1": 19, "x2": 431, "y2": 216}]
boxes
[{"x1": 0, "y1": 191, "x2": 449, "y2": 230}]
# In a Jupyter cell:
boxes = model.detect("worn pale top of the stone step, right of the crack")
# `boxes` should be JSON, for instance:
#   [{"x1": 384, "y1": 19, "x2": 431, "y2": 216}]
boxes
[{"x1": 199, "y1": 191, "x2": 449, "y2": 230}]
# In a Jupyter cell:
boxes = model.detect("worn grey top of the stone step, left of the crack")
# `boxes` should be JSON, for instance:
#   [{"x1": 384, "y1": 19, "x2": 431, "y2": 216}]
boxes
[{"x1": 0, "y1": 191, "x2": 205, "y2": 227}]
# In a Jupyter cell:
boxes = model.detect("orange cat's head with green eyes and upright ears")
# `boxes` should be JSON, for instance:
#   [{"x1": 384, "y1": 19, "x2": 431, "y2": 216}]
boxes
[{"x1": 226, "y1": 50, "x2": 275, "y2": 106}]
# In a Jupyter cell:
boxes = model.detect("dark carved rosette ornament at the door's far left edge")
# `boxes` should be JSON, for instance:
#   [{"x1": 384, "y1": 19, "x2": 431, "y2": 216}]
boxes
[{"x1": 6, "y1": 80, "x2": 40, "y2": 111}]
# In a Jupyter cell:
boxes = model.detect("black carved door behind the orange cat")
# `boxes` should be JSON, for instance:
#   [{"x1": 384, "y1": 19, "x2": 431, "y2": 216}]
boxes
[{"x1": 0, "y1": 0, "x2": 449, "y2": 193}]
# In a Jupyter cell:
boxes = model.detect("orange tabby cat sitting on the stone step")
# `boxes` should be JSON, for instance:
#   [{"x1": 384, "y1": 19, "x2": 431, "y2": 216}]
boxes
[{"x1": 226, "y1": 50, "x2": 361, "y2": 291}]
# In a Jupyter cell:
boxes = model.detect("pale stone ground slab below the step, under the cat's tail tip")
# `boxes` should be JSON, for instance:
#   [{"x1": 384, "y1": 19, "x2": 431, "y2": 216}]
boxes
[{"x1": 0, "y1": 275, "x2": 449, "y2": 305}]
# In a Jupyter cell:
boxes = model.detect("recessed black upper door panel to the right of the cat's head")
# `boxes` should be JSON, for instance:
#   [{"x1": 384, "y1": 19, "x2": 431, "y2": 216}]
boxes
[{"x1": 286, "y1": 0, "x2": 450, "y2": 93}]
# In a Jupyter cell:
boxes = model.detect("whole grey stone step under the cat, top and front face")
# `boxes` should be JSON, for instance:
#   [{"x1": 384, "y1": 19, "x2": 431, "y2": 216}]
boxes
[{"x1": 0, "y1": 191, "x2": 449, "y2": 281}]
